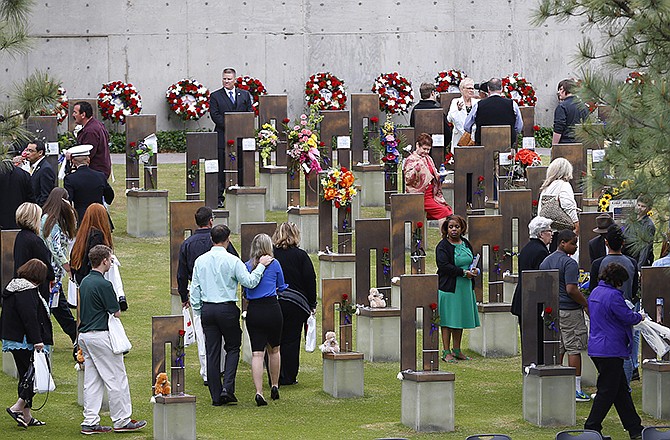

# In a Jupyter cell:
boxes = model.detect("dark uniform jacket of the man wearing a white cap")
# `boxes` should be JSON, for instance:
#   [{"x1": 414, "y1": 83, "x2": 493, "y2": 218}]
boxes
[{"x1": 63, "y1": 165, "x2": 114, "y2": 222}]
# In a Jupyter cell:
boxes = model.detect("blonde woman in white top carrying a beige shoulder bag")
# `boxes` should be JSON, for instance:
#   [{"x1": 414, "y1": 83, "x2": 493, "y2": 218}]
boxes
[{"x1": 537, "y1": 157, "x2": 579, "y2": 252}]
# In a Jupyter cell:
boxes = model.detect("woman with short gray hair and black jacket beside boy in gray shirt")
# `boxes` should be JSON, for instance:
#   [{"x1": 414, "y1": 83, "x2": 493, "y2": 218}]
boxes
[{"x1": 511, "y1": 216, "x2": 552, "y2": 326}]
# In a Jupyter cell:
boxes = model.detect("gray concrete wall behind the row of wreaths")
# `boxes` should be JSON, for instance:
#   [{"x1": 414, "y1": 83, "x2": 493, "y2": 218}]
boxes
[{"x1": 0, "y1": 0, "x2": 600, "y2": 129}]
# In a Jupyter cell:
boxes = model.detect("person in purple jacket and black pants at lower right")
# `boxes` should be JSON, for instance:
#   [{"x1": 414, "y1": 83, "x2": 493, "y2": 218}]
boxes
[{"x1": 584, "y1": 263, "x2": 644, "y2": 439}]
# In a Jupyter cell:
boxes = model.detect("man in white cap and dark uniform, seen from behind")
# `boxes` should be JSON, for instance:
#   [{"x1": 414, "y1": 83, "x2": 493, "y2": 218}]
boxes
[{"x1": 63, "y1": 145, "x2": 114, "y2": 222}]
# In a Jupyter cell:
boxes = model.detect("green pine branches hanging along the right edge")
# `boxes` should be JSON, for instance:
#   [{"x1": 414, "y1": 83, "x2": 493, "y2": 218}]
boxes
[{"x1": 532, "y1": 0, "x2": 670, "y2": 241}]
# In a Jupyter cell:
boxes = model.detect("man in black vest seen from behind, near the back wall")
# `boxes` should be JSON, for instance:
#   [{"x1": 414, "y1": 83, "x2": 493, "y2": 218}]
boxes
[{"x1": 463, "y1": 78, "x2": 523, "y2": 146}]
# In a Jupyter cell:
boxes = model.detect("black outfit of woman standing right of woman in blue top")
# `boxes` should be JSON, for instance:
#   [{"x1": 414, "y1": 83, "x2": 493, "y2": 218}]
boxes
[{"x1": 274, "y1": 247, "x2": 316, "y2": 385}]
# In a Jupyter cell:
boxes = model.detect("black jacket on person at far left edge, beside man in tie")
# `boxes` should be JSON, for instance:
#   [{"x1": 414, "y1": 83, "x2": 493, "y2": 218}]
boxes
[{"x1": 0, "y1": 163, "x2": 35, "y2": 229}]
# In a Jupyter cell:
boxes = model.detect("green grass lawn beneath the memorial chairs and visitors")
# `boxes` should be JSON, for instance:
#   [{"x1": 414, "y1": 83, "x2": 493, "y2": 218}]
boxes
[{"x1": 0, "y1": 165, "x2": 669, "y2": 440}]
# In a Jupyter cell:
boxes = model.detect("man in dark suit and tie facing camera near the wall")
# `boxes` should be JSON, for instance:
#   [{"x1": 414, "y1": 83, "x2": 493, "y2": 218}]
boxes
[{"x1": 209, "y1": 67, "x2": 253, "y2": 207}]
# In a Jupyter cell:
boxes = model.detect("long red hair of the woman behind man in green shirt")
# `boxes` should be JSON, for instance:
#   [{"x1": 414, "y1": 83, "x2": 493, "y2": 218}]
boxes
[{"x1": 70, "y1": 203, "x2": 114, "y2": 285}]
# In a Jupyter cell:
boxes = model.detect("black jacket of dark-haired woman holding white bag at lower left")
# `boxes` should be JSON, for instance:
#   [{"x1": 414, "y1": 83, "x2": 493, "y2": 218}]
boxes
[{"x1": 0, "y1": 278, "x2": 53, "y2": 345}]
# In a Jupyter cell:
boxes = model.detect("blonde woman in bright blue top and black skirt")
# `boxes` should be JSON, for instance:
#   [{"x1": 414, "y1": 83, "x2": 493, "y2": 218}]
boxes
[{"x1": 244, "y1": 234, "x2": 288, "y2": 406}]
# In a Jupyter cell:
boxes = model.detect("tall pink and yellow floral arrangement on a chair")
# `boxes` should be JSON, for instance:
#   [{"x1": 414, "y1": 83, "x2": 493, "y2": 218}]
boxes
[{"x1": 286, "y1": 105, "x2": 323, "y2": 174}]
